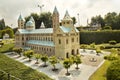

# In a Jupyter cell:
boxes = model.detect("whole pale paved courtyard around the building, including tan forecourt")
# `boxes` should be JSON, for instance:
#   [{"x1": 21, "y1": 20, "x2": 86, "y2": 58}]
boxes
[{"x1": 6, "y1": 49, "x2": 110, "y2": 80}]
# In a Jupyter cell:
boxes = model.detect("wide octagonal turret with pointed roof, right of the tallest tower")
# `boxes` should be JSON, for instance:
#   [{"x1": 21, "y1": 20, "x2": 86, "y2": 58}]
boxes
[{"x1": 62, "y1": 11, "x2": 73, "y2": 27}]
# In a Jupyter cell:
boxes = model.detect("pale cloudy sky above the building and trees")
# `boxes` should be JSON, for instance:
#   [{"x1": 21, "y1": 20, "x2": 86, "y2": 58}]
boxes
[{"x1": 0, "y1": 0, "x2": 120, "y2": 28}]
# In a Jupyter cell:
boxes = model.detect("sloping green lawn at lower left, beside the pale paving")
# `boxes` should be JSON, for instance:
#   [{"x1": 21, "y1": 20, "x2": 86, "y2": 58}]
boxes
[{"x1": 0, "y1": 54, "x2": 52, "y2": 80}]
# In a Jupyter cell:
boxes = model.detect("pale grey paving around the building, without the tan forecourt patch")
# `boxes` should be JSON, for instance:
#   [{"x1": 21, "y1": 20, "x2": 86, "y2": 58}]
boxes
[{"x1": 6, "y1": 50, "x2": 109, "y2": 80}]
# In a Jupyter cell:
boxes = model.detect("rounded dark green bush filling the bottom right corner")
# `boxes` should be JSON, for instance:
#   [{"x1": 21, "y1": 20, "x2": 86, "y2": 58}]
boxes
[{"x1": 106, "y1": 60, "x2": 120, "y2": 80}]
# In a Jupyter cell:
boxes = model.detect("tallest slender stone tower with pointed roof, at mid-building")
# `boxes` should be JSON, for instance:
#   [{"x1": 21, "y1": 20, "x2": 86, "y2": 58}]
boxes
[{"x1": 52, "y1": 6, "x2": 59, "y2": 33}]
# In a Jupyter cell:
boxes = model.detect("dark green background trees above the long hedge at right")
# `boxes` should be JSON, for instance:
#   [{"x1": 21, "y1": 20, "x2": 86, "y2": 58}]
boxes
[{"x1": 90, "y1": 12, "x2": 120, "y2": 30}]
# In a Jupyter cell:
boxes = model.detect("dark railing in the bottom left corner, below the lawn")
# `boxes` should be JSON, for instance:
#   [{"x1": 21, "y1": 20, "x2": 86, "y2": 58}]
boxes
[{"x1": 0, "y1": 70, "x2": 21, "y2": 80}]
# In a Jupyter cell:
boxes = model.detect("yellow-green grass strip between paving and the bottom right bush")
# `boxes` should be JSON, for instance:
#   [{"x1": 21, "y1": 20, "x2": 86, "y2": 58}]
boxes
[{"x1": 89, "y1": 60, "x2": 111, "y2": 80}]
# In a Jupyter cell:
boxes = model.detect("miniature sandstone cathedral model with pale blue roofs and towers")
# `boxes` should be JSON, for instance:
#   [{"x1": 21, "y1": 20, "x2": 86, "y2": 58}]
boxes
[{"x1": 15, "y1": 7, "x2": 79, "y2": 58}]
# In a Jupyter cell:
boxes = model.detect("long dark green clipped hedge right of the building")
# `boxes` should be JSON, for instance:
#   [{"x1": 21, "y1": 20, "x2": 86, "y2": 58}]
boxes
[{"x1": 80, "y1": 30, "x2": 120, "y2": 44}]
